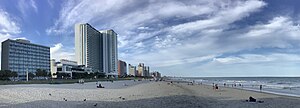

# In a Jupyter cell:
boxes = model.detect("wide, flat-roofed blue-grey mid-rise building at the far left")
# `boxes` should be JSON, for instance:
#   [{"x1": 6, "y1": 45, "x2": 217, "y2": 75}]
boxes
[{"x1": 1, "y1": 39, "x2": 50, "y2": 79}]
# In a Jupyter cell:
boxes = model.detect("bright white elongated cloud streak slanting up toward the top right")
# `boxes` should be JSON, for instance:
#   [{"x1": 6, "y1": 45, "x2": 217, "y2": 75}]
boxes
[{"x1": 171, "y1": 0, "x2": 266, "y2": 33}]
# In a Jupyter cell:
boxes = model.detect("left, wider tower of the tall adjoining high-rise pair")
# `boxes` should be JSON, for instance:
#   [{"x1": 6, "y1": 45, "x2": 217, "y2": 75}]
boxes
[{"x1": 75, "y1": 23, "x2": 103, "y2": 72}]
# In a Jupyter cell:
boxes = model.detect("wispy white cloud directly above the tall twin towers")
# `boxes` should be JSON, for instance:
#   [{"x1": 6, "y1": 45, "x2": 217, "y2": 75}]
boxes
[{"x1": 46, "y1": 0, "x2": 130, "y2": 34}]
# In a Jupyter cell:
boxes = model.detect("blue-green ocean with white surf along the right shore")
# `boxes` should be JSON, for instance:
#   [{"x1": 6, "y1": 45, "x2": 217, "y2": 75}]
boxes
[{"x1": 181, "y1": 77, "x2": 300, "y2": 97}]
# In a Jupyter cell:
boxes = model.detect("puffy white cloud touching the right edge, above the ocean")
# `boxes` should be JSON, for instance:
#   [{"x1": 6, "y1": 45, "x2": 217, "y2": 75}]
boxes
[{"x1": 230, "y1": 16, "x2": 300, "y2": 49}]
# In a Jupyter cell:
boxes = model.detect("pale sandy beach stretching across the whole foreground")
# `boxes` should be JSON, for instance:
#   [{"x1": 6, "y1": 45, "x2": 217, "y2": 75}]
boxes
[{"x1": 0, "y1": 81, "x2": 300, "y2": 108}]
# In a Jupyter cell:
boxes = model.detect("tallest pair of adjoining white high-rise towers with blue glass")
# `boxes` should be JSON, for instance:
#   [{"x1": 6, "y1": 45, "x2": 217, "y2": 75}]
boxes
[{"x1": 75, "y1": 23, "x2": 118, "y2": 76}]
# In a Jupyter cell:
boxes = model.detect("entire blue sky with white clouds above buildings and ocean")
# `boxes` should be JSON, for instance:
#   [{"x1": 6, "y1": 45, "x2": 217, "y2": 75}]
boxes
[{"x1": 0, "y1": 0, "x2": 300, "y2": 77}]
